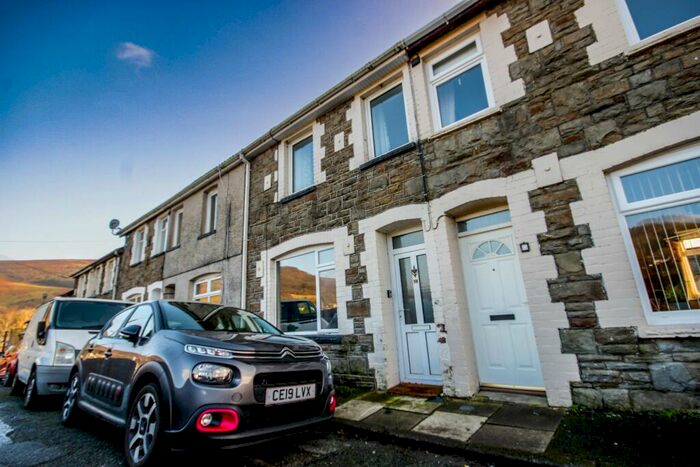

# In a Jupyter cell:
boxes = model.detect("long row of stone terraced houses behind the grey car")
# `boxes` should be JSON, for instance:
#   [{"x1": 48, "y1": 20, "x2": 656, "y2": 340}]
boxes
[{"x1": 86, "y1": 0, "x2": 700, "y2": 408}]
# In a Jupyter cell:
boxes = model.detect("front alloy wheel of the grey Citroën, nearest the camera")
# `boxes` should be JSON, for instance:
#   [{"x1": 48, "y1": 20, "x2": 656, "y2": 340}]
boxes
[{"x1": 124, "y1": 384, "x2": 164, "y2": 466}]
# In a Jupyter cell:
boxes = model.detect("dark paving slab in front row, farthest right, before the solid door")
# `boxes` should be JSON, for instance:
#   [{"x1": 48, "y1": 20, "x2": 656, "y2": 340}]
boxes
[{"x1": 468, "y1": 423, "x2": 554, "y2": 454}]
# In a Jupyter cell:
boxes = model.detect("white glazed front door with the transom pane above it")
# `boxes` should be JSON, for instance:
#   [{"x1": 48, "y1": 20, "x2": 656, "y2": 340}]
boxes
[{"x1": 391, "y1": 231, "x2": 442, "y2": 384}]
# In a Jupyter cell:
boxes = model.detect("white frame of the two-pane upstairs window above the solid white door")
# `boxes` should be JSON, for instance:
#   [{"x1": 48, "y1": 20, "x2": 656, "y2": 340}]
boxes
[{"x1": 426, "y1": 33, "x2": 495, "y2": 131}]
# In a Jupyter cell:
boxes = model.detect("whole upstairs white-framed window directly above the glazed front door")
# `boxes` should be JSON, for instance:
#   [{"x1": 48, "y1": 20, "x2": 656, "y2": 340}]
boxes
[{"x1": 365, "y1": 82, "x2": 409, "y2": 158}]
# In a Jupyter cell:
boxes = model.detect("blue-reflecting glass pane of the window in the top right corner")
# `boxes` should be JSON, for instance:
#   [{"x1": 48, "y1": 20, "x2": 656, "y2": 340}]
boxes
[{"x1": 627, "y1": 0, "x2": 700, "y2": 39}]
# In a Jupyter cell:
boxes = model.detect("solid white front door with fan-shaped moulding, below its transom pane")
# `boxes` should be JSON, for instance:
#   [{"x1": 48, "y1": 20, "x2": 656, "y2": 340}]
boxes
[{"x1": 459, "y1": 227, "x2": 544, "y2": 388}]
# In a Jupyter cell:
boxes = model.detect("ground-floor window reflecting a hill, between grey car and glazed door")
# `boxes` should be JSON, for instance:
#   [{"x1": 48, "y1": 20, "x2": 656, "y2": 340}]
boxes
[{"x1": 277, "y1": 246, "x2": 338, "y2": 334}]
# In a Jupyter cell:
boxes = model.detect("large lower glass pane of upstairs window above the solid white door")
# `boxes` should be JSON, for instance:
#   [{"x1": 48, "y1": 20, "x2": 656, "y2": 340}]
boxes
[{"x1": 437, "y1": 65, "x2": 489, "y2": 126}]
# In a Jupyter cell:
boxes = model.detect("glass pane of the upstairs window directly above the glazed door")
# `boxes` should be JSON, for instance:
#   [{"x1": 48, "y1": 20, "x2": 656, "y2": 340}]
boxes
[{"x1": 370, "y1": 86, "x2": 408, "y2": 156}]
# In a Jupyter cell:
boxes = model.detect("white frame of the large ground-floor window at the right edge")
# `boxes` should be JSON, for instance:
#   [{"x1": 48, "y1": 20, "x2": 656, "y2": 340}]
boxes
[{"x1": 608, "y1": 143, "x2": 700, "y2": 325}]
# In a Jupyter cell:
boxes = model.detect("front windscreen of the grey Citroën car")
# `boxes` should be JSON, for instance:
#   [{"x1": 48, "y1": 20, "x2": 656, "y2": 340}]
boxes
[{"x1": 161, "y1": 302, "x2": 282, "y2": 334}]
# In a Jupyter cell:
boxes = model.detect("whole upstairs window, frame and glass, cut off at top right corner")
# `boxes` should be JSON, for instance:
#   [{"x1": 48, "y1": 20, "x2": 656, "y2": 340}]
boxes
[{"x1": 617, "y1": 0, "x2": 700, "y2": 44}]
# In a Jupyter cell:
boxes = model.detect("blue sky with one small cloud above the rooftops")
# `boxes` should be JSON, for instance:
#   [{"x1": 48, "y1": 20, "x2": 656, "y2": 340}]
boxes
[{"x1": 0, "y1": 0, "x2": 456, "y2": 259}]
